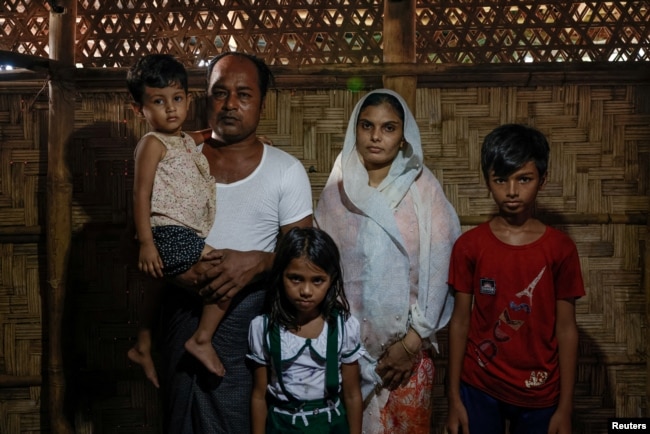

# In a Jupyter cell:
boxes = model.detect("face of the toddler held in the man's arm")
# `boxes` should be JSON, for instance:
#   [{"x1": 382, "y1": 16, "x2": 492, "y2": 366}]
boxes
[{"x1": 133, "y1": 84, "x2": 191, "y2": 134}]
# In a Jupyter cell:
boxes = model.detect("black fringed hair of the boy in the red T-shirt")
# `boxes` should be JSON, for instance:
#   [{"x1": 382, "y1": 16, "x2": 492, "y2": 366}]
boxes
[{"x1": 481, "y1": 124, "x2": 550, "y2": 182}]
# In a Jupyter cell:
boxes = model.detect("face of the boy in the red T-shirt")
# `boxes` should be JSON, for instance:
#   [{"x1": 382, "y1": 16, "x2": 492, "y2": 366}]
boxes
[{"x1": 488, "y1": 161, "x2": 546, "y2": 216}]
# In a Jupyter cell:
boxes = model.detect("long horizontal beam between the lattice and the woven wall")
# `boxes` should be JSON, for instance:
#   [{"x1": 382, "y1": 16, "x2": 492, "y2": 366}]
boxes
[{"x1": 0, "y1": 62, "x2": 650, "y2": 93}]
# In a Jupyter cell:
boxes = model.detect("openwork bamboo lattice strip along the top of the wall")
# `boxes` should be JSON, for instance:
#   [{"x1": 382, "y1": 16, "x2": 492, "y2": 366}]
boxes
[{"x1": 0, "y1": 0, "x2": 650, "y2": 67}]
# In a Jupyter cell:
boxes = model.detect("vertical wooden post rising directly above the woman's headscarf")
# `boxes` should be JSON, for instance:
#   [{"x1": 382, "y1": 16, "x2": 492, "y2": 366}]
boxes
[{"x1": 383, "y1": 0, "x2": 418, "y2": 113}]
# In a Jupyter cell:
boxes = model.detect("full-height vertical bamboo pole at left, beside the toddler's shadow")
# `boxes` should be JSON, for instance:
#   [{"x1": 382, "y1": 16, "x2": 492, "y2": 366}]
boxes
[{"x1": 44, "y1": 0, "x2": 77, "y2": 434}]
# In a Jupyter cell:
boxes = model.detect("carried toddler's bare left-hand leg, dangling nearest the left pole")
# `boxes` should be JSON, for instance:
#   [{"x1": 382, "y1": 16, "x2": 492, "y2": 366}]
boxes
[{"x1": 126, "y1": 278, "x2": 163, "y2": 388}]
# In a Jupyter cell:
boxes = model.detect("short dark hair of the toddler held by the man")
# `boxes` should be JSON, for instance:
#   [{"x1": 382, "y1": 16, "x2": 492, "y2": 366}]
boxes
[{"x1": 126, "y1": 54, "x2": 188, "y2": 104}]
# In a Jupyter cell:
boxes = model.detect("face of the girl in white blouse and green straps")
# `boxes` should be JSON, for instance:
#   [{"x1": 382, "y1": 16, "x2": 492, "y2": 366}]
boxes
[{"x1": 282, "y1": 257, "x2": 332, "y2": 323}]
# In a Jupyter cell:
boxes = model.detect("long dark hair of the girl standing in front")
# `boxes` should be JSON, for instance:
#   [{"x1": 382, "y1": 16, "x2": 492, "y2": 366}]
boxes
[{"x1": 267, "y1": 227, "x2": 350, "y2": 330}]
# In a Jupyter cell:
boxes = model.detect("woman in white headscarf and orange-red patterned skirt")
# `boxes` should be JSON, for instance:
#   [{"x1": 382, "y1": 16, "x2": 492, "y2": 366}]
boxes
[{"x1": 315, "y1": 89, "x2": 460, "y2": 434}]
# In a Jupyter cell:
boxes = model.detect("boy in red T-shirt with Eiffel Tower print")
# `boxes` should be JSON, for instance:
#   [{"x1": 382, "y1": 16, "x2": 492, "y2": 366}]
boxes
[{"x1": 447, "y1": 124, "x2": 585, "y2": 434}]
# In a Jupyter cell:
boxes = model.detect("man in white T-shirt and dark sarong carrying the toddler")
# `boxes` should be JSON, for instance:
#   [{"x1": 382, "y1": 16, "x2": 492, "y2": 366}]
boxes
[{"x1": 163, "y1": 52, "x2": 312, "y2": 434}]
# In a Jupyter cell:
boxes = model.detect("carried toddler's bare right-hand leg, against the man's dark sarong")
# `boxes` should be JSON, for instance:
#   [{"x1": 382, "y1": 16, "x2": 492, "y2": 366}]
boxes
[{"x1": 185, "y1": 301, "x2": 230, "y2": 377}]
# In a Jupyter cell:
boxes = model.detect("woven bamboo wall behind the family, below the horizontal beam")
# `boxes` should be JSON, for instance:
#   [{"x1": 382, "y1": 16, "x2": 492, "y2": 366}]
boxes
[{"x1": 0, "y1": 80, "x2": 650, "y2": 434}]
